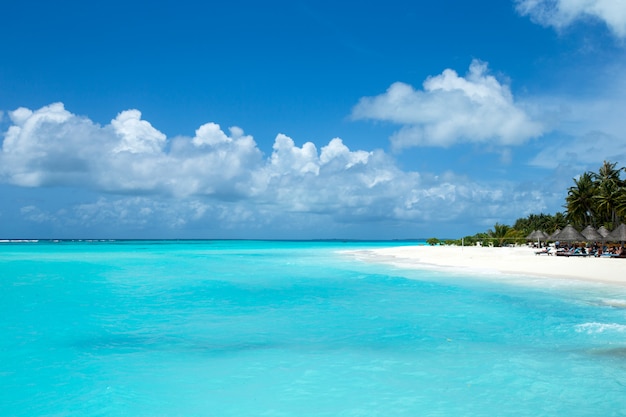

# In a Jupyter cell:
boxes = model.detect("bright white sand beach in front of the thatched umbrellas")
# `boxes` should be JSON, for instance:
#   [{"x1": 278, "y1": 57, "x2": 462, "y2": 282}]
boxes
[{"x1": 347, "y1": 246, "x2": 626, "y2": 286}]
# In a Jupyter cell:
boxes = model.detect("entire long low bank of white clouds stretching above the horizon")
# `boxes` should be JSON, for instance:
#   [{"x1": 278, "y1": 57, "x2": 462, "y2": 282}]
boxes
[{"x1": 0, "y1": 102, "x2": 552, "y2": 234}]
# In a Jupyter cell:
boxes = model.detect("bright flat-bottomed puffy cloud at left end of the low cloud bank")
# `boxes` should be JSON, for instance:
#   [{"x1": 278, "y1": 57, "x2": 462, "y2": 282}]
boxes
[{"x1": 0, "y1": 103, "x2": 262, "y2": 196}]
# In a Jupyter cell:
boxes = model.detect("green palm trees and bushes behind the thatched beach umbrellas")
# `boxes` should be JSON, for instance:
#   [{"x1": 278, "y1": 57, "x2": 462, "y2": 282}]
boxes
[{"x1": 428, "y1": 161, "x2": 626, "y2": 246}]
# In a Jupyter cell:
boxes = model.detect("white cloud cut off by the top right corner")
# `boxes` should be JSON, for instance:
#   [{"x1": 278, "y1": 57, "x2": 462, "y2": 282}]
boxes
[{"x1": 516, "y1": 0, "x2": 626, "y2": 38}]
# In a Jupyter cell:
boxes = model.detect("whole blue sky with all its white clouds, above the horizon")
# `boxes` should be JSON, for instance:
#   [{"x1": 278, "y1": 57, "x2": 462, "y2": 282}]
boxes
[{"x1": 0, "y1": 0, "x2": 626, "y2": 239}]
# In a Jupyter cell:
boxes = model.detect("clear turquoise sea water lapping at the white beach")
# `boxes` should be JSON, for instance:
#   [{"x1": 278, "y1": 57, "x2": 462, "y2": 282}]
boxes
[{"x1": 0, "y1": 241, "x2": 626, "y2": 417}]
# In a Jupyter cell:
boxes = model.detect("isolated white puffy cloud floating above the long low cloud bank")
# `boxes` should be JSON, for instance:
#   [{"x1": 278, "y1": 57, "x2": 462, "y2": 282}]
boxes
[{"x1": 352, "y1": 60, "x2": 544, "y2": 149}]
